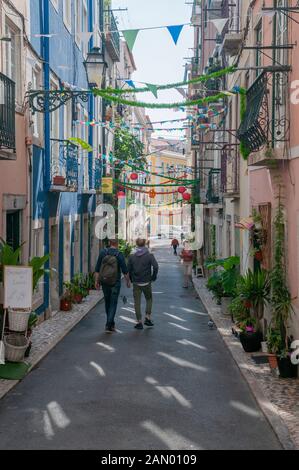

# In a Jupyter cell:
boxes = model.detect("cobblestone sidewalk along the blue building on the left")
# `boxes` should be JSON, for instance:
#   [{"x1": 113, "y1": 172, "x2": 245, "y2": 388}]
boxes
[{"x1": 0, "y1": 291, "x2": 103, "y2": 399}]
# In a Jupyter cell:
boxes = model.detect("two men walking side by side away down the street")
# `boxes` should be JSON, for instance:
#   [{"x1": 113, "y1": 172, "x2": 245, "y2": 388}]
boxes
[{"x1": 95, "y1": 239, "x2": 159, "y2": 333}]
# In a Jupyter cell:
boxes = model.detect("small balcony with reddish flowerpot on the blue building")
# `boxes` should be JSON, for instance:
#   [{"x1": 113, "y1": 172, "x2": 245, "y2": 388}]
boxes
[{"x1": 50, "y1": 139, "x2": 79, "y2": 192}]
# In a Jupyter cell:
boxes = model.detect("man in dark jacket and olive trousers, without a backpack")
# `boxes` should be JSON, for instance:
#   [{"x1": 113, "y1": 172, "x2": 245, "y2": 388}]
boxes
[{"x1": 128, "y1": 238, "x2": 159, "y2": 330}]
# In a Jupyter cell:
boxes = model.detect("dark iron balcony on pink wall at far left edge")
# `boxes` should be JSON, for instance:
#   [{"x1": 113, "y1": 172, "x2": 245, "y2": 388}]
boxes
[{"x1": 0, "y1": 73, "x2": 16, "y2": 160}]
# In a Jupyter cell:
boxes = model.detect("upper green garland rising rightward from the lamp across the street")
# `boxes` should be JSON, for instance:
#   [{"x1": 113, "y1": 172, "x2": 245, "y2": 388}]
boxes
[{"x1": 102, "y1": 66, "x2": 236, "y2": 95}]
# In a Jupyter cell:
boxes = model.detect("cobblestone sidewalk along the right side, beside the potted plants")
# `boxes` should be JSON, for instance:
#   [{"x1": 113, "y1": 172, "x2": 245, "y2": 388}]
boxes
[{"x1": 193, "y1": 278, "x2": 299, "y2": 450}]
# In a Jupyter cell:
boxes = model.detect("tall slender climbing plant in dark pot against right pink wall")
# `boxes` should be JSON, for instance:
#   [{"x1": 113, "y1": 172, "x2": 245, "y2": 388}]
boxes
[{"x1": 270, "y1": 199, "x2": 297, "y2": 378}]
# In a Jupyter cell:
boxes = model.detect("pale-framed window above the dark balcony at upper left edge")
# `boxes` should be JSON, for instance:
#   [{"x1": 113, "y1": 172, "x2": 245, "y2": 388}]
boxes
[{"x1": 5, "y1": 19, "x2": 22, "y2": 101}]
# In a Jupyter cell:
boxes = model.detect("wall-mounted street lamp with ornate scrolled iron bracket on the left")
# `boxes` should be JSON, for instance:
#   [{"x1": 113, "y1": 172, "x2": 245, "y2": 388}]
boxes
[{"x1": 27, "y1": 47, "x2": 108, "y2": 113}]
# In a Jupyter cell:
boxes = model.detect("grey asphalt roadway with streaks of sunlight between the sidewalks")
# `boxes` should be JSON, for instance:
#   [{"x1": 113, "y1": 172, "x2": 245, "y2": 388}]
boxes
[{"x1": 0, "y1": 246, "x2": 280, "y2": 450}]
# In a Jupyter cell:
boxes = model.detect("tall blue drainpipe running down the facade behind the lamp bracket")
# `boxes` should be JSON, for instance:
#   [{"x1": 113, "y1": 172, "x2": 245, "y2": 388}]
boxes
[{"x1": 42, "y1": 0, "x2": 51, "y2": 309}]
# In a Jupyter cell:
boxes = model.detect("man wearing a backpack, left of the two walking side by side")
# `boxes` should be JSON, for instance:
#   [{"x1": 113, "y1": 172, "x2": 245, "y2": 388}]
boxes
[{"x1": 95, "y1": 240, "x2": 131, "y2": 333}]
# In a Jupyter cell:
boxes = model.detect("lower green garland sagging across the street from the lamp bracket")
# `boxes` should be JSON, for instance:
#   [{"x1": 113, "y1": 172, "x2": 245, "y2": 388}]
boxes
[{"x1": 93, "y1": 89, "x2": 233, "y2": 109}]
